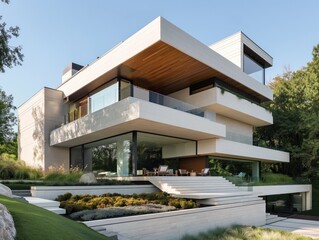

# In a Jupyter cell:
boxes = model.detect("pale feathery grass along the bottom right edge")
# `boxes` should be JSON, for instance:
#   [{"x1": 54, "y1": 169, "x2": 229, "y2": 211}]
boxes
[{"x1": 182, "y1": 226, "x2": 318, "y2": 240}]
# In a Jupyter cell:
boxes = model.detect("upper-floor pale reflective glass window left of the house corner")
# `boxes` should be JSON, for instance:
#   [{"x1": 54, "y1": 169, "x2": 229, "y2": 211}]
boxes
[{"x1": 90, "y1": 79, "x2": 119, "y2": 113}]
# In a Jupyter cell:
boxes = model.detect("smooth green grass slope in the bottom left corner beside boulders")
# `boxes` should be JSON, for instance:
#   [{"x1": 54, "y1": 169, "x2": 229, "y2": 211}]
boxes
[{"x1": 0, "y1": 195, "x2": 108, "y2": 240}]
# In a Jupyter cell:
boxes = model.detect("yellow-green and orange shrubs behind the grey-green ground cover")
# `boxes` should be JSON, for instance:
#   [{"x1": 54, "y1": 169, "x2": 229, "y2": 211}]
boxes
[{"x1": 56, "y1": 192, "x2": 198, "y2": 214}]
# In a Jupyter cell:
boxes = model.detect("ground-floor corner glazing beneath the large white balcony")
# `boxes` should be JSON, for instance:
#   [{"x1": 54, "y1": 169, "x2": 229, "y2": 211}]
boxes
[{"x1": 70, "y1": 132, "x2": 196, "y2": 176}]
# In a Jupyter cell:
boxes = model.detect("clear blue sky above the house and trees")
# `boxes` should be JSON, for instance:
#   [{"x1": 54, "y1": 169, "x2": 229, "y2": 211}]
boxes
[{"x1": 0, "y1": 0, "x2": 319, "y2": 106}]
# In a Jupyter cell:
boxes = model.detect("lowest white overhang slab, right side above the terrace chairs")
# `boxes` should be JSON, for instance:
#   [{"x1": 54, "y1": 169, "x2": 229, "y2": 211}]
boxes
[{"x1": 198, "y1": 139, "x2": 289, "y2": 162}]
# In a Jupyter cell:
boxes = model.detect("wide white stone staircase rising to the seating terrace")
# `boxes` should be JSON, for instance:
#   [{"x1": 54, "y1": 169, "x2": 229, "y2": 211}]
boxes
[{"x1": 149, "y1": 176, "x2": 263, "y2": 206}]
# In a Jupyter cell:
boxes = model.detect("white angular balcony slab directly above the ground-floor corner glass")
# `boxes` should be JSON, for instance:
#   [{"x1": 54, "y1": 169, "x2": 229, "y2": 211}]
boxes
[{"x1": 50, "y1": 97, "x2": 226, "y2": 147}]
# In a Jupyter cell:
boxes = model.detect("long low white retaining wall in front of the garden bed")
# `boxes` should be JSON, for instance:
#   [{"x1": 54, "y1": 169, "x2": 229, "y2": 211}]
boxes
[{"x1": 84, "y1": 201, "x2": 266, "y2": 240}]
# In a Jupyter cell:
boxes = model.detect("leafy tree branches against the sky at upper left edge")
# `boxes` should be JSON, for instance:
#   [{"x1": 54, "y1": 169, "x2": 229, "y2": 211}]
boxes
[{"x1": 0, "y1": 0, "x2": 23, "y2": 72}]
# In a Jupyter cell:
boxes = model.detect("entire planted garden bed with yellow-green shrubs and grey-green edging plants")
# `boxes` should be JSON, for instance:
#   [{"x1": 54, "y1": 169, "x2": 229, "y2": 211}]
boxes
[{"x1": 56, "y1": 192, "x2": 199, "y2": 221}]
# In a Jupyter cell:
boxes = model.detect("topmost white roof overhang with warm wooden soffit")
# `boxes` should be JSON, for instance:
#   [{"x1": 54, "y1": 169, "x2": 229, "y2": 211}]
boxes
[{"x1": 58, "y1": 17, "x2": 273, "y2": 101}]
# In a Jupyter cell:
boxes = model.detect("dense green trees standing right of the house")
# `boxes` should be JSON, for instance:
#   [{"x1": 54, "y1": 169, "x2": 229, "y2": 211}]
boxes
[{"x1": 255, "y1": 44, "x2": 319, "y2": 179}]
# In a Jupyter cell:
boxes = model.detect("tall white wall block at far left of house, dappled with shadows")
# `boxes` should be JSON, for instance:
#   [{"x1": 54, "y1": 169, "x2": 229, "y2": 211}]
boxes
[{"x1": 18, "y1": 88, "x2": 69, "y2": 171}]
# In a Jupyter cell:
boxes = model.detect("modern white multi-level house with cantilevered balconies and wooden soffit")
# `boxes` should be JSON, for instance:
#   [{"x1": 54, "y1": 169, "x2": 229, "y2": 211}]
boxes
[{"x1": 18, "y1": 17, "x2": 311, "y2": 216}]
